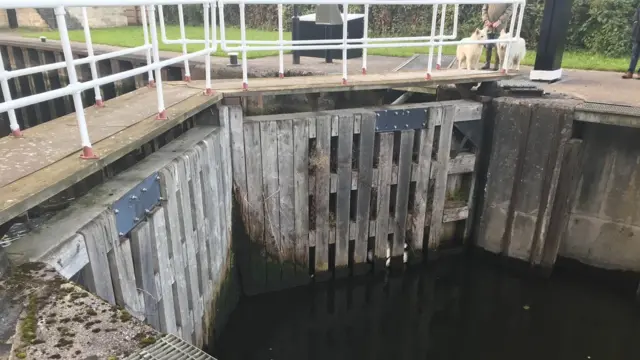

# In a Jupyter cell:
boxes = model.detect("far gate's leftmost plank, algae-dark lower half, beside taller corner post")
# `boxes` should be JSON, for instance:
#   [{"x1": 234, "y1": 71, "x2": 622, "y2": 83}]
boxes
[{"x1": 244, "y1": 123, "x2": 267, "y2": 294}]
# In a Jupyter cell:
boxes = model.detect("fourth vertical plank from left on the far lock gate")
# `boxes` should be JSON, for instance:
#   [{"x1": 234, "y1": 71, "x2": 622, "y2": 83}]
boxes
[{"x1": 293, "y1": 119, "x2": 309, "y2": 283}]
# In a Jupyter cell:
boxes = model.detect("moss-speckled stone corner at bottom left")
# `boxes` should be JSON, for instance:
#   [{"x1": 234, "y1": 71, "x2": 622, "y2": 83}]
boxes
[{"x1": 0, "y1": 263, "x2": 159, "y2": 360}]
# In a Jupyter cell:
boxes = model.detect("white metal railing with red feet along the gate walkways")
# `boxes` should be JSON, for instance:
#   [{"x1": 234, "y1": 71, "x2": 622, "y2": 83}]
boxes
[{"x1": 0, "y1": 0, "x2": 526, "y2": 159}]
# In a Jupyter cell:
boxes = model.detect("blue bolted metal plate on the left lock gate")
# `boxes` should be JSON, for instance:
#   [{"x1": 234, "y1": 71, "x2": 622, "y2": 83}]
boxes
[{"x1": 112, "y1": 172, "x2": 162, "y2": 236}]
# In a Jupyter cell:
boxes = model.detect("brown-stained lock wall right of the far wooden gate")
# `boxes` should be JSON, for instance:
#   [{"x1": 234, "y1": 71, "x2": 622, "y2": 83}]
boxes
[{"x1": 477, "y1": 98, "x2": 640, "y2": 271}]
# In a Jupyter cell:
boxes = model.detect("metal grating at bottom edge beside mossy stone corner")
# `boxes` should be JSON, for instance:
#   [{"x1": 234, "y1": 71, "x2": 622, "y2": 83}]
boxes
[{"x1": 125, "y1": 334, "x2": 215, "y2": 360}]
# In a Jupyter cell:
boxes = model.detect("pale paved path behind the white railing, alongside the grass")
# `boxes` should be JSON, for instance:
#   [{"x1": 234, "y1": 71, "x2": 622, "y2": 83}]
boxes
[{"x1": 0, "y1": 32, "x2": 640, "y2": 106}]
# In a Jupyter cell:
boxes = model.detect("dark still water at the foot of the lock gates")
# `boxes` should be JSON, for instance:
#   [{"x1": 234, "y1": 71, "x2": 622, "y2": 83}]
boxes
[{"x1": 213, "y1": 253, "x2": 640, "y2": 360}]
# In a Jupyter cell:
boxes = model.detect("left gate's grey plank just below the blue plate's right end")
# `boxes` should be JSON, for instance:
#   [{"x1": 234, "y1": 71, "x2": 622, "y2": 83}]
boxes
[{"x1": 151, "y1": 207, "x2": 180, "y2": 336}]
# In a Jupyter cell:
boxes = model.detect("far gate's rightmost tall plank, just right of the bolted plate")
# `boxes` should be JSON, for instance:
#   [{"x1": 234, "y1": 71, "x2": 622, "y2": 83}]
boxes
[{"x1": 429, "y1": 105, "x2": 455, "y2": 250}]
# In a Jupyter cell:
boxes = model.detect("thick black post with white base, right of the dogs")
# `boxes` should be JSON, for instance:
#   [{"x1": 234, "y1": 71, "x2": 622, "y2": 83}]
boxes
[{"x1": 530, "y1": 0, "x2": 573, "y2": 82}]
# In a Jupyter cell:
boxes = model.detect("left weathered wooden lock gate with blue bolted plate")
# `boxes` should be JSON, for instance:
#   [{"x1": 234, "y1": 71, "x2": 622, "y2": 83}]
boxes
[{"x1": 9, "y1": 107, "x2": 238, "y2": 347}]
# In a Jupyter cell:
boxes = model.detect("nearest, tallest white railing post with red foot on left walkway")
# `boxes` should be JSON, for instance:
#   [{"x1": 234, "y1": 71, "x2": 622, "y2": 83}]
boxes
[{"x1": 54, "y1": 6, "x2": 98, "y2": 159}]
